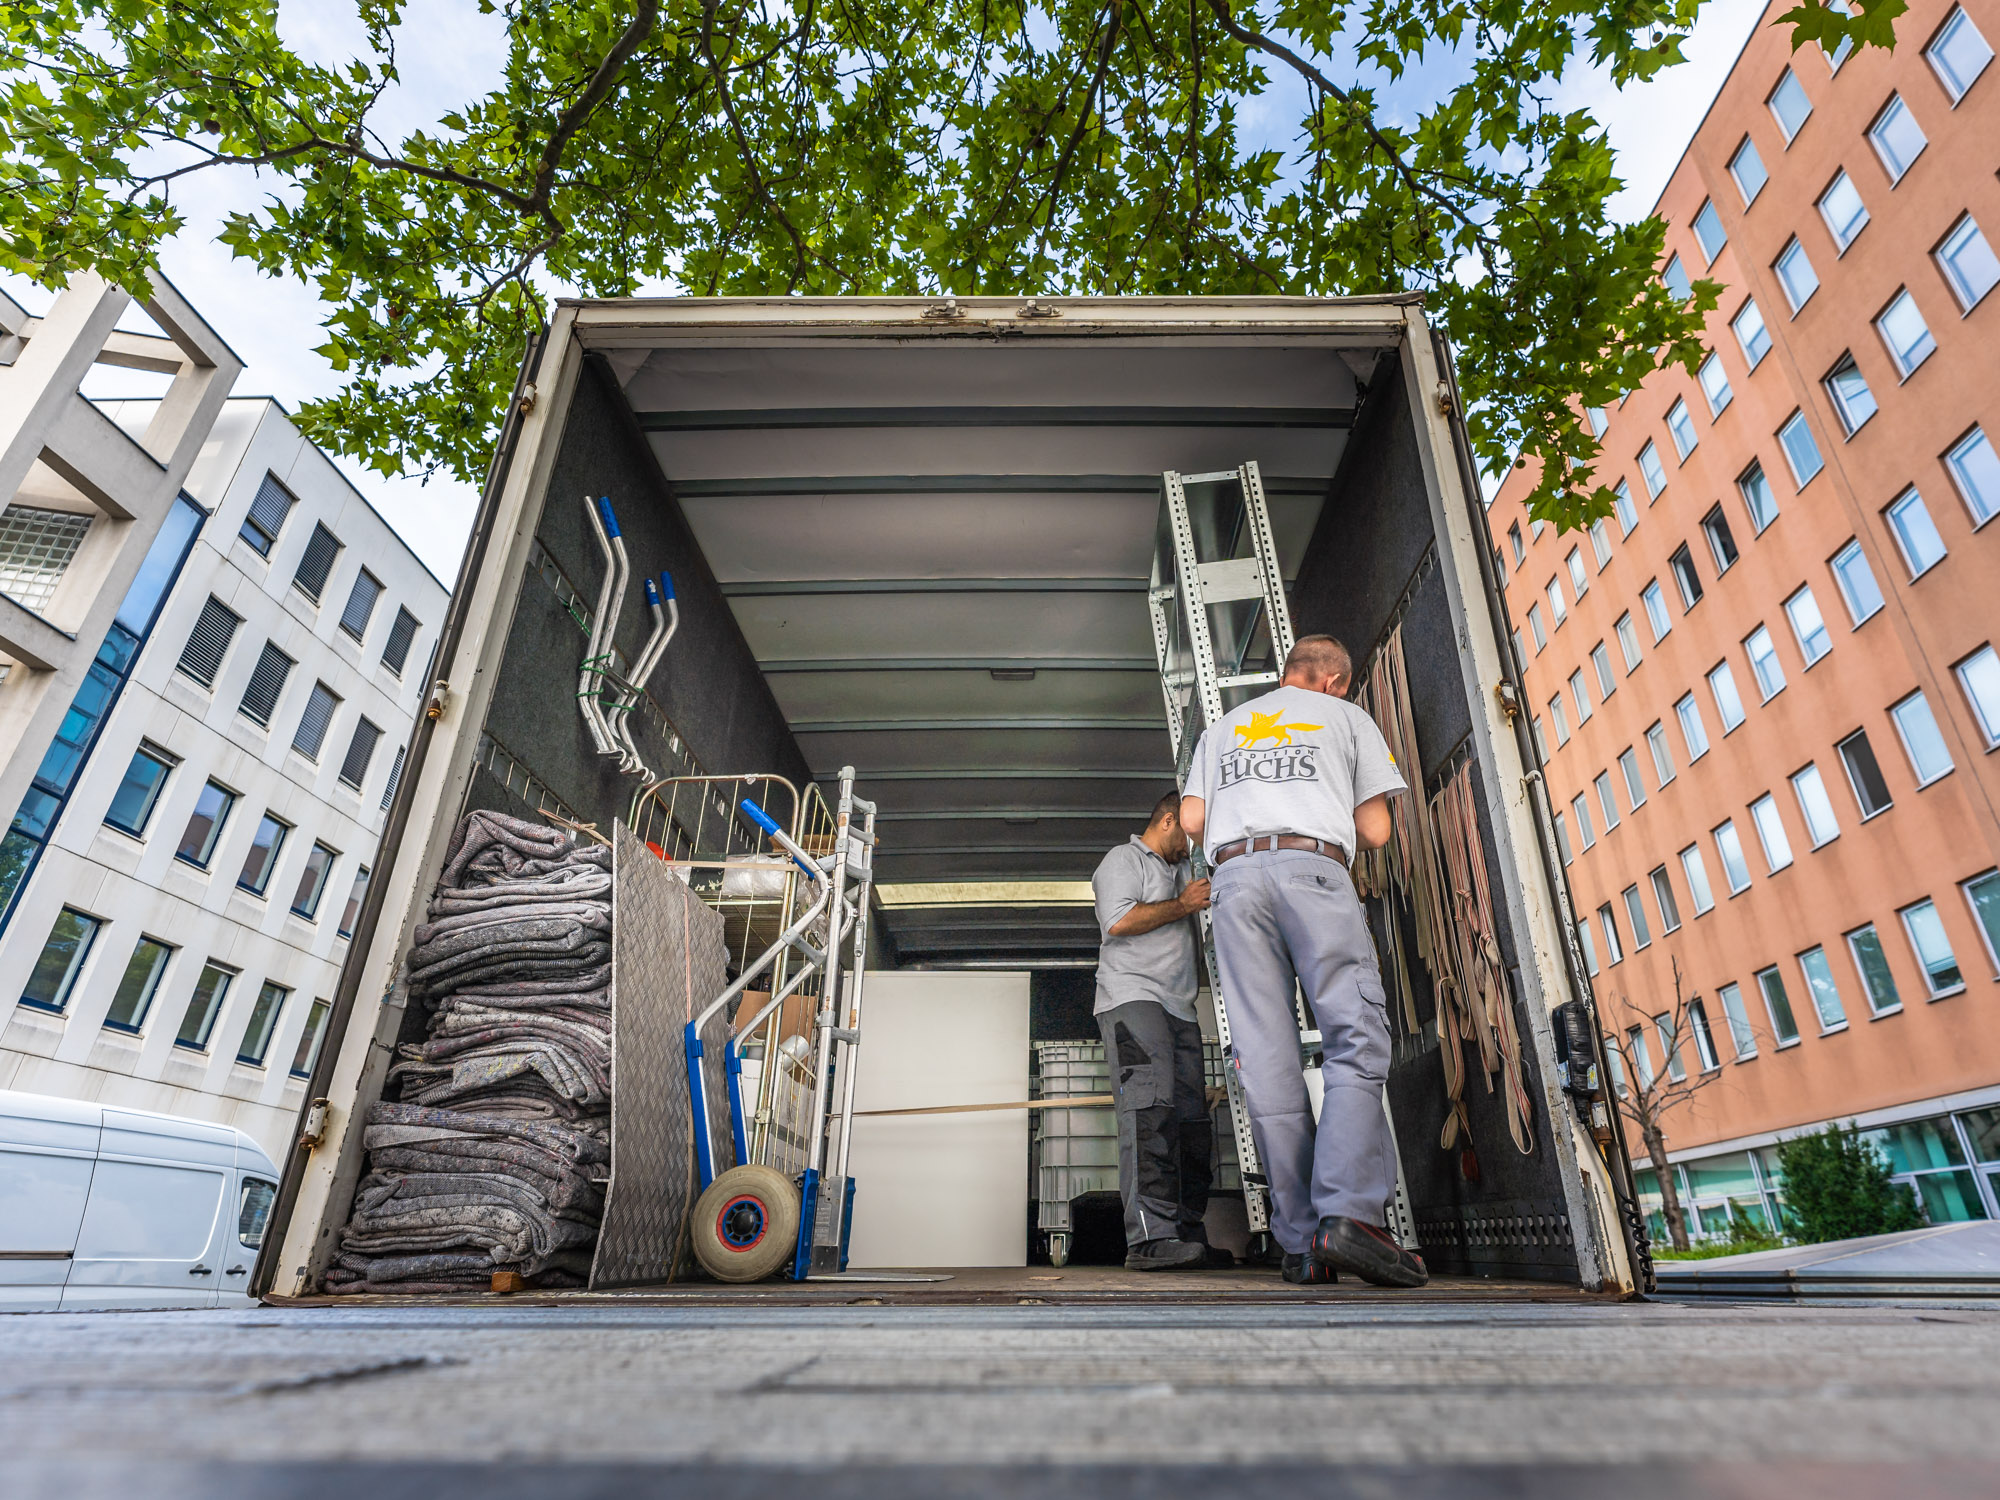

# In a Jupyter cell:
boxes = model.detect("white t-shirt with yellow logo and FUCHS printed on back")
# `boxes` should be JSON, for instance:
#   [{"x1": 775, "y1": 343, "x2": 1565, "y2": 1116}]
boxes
[{"x1": 1182, "y1": 688, "x2": 1408, "y2": 860}]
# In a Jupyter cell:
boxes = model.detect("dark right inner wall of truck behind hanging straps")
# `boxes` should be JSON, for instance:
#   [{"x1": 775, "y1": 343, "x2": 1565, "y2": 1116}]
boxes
[{"x1": 1292, "y1": 360, "x2": 1578, "y2": 1282}]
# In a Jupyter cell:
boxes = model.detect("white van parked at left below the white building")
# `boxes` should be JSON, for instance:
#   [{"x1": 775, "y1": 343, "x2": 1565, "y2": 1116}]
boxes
[{"x1": 0, "y1": 1090, "x2": 278, "y2": 1312}]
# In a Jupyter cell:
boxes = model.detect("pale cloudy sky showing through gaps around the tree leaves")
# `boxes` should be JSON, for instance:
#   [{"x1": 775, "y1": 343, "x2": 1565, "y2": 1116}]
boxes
[{"x1": 11, "y1": 0, "x2": 1764, "y2": 582}]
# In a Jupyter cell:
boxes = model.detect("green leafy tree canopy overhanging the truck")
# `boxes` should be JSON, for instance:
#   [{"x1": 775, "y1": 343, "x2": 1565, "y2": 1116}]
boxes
[{"x1": 0, "y1": 0, "x2": 1904, "y2": 524}]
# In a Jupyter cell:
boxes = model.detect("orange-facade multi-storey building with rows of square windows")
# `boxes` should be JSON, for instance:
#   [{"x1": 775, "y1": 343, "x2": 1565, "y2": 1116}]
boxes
[{"x1": 1488, "y1": 0, "x2": 2000, "y2": 1234}]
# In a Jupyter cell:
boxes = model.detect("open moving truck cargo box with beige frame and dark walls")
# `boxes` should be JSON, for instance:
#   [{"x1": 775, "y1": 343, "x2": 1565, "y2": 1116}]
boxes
[{"x1": 258, "y1": 298, "x2": 1648, "y2": 1296}]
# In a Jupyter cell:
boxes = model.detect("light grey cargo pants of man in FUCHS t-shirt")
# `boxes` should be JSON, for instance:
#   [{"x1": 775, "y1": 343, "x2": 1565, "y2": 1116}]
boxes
[{"x1": 1210, "y1": 850, "x2": 1396, "y2": 1254}]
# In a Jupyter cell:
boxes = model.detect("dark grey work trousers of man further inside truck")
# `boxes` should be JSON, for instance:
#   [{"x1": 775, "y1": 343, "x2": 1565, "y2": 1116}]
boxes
[{"x1": 1098, "y1": 1000, "x2": 1216, "y2": 1250}]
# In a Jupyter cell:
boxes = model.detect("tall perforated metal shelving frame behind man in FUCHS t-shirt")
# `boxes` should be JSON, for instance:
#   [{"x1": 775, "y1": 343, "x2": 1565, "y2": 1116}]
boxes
[{"x1": 1146, "y1": 460, "x2": 1416, "y2": 1246}]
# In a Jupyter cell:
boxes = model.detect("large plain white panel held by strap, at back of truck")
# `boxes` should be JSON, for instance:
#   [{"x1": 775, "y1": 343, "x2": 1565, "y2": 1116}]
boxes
[{"x1": 848, "y1": 970, "x2": 1028, "y2": 1270}]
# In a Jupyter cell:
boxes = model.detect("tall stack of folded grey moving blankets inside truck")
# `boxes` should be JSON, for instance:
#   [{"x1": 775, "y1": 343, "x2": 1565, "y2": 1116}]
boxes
[{"x1": 326, "y1": 810, "x2": 612, "y2": 1292}]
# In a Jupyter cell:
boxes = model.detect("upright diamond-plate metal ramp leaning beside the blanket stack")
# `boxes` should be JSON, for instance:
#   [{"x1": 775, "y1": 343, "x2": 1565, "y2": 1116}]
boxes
[{"x1": 590, "y1": 822, "x2": 734, "y2": 1292}]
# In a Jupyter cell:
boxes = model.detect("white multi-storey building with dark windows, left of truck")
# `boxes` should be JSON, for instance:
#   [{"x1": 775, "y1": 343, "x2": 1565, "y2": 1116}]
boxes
[{"x1": 0, "y1": 398, "x2": 448, "y2": 1160}]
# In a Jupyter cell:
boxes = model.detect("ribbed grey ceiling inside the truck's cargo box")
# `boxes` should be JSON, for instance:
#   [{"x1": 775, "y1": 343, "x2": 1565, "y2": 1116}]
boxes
[{"x1": 608, "y1": 328, "x2": 1382, "y2": 968}]
